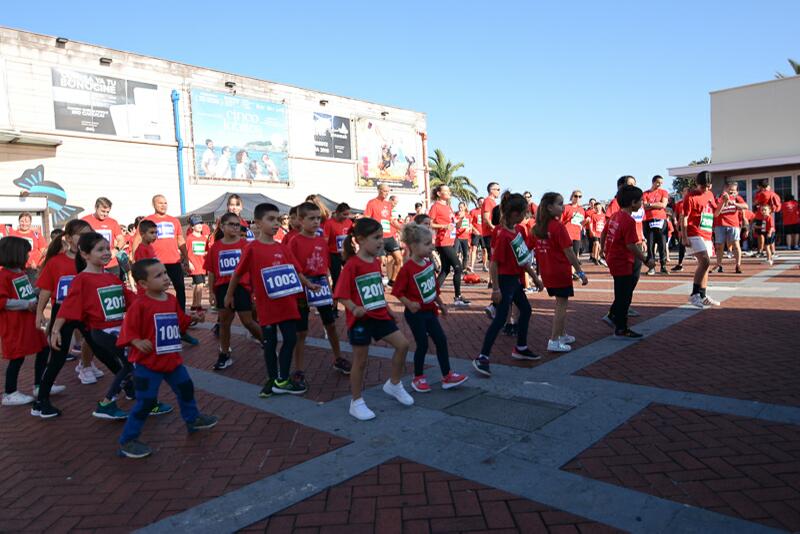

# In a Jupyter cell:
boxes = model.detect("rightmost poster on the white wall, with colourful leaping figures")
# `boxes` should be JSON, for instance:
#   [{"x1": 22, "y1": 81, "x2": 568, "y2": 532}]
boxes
[{"x1": 356, "y1": 118, "x2": 423, "y2": 190}]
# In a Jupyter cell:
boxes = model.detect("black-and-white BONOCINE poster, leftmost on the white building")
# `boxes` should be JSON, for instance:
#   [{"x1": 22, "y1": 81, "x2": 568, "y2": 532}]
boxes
[{"x1": 51, "y1": 67, "x2": 161, "y2": 140}]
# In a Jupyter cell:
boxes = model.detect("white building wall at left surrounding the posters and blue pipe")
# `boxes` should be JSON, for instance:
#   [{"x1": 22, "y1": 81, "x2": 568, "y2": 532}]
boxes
[{"x1": 0, "y1": 28, "x2": 426, "y2": 227}]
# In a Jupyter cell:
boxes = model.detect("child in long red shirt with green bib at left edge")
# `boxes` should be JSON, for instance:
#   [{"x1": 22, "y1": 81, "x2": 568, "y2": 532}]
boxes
[{"x1": 0, "y1": 237, "x2": 48, "y2": 406}]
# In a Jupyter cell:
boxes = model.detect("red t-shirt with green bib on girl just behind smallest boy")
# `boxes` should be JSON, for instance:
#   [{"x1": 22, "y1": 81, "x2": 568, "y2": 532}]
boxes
[{"x1": 57, "y1": 271, "x2": 136, "y2": 332}]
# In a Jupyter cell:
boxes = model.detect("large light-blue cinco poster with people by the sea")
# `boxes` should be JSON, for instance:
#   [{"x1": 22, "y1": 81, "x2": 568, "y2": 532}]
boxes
[{"x1": 192, "y1": 89, "x2": 289, "y2": 184}]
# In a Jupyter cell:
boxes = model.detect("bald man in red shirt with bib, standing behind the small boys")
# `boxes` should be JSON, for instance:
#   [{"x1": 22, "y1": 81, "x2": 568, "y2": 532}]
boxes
[{"x1": 133, "y1": 195, "x2": 190, "y2": 310}]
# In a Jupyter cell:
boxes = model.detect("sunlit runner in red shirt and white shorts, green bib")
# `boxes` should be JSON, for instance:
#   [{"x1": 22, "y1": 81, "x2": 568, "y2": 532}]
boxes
[{"x1": 681, "y1": 171, "x2": 722, "y2": 308}]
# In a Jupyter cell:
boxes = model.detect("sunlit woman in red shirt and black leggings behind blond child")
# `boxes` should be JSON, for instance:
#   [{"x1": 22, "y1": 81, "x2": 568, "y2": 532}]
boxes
[{"x1": 428, "y1": 185, "x2": 469, "y2": 306}]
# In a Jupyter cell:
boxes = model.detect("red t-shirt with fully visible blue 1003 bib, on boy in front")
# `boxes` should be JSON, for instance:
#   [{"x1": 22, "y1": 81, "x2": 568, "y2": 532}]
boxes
[{"x1": 236, "y1": 240, "x2": 304, "y2": 326}]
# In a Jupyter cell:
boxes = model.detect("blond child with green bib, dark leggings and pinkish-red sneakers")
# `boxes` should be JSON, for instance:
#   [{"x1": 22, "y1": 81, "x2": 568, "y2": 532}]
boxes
[{"x1": 392, "y1": 223, "x2": 468, "y2": 393}]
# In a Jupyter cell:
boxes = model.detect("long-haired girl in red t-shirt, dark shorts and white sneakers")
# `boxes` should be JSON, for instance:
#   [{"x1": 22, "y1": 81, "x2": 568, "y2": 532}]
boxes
[{"x1": 533, "y1": 193, "x2": 589, "y2": 352}]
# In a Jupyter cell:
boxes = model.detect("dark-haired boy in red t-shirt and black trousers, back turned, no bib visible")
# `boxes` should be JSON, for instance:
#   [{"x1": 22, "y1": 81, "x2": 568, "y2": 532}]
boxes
[{"x1": 603, "y1": 185, "x2": 656, "y2": 339}]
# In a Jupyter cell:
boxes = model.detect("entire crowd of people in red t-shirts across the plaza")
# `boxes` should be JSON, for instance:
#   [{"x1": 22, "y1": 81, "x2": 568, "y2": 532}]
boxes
[{"x1": 0, "y1": 172, "x2": 800, "y2": 458}]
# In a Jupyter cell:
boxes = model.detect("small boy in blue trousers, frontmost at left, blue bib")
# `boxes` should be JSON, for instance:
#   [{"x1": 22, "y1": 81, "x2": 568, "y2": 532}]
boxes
[{"x1": 117, "y1": 258, "x2": 217, "y2": 458}]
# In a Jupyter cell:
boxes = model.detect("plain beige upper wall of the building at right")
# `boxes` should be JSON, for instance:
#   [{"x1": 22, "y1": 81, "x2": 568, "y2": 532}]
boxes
[{"x1": 711, "y1": 76, "x2": 800, "y2": 163}]
